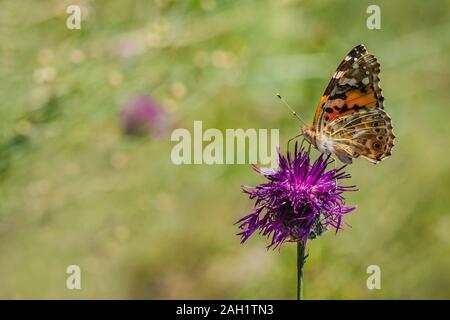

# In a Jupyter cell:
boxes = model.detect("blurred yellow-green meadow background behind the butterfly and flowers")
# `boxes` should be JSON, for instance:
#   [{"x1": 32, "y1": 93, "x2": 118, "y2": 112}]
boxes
[{"x1": 0, "y1": 0, "x2": 450, "y2": 299}]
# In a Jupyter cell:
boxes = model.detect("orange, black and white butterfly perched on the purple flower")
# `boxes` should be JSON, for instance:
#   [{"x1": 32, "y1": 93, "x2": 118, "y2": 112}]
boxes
[{"x1": 302, "y1": 44, "x2": 395, "y2": 164}]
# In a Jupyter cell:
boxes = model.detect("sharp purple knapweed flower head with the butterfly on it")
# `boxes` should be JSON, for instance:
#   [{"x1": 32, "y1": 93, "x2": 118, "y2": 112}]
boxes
[{"x1": 237, "y1": 145, "x2": 357, "y2": 248}]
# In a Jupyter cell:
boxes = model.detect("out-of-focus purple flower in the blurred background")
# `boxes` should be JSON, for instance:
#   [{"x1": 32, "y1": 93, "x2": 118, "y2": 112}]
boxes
[{"x1": 120, "y1": 96, "x2": 171, "y2": 137}]
